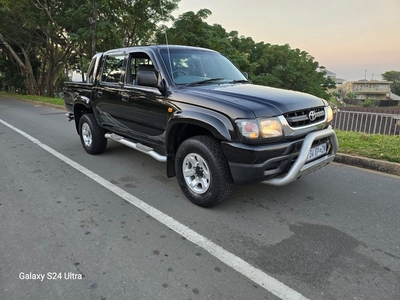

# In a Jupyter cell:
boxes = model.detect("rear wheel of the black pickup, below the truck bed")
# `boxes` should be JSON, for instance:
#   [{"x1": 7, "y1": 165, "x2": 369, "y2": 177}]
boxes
[{"x1": 79, "y1": 114, "x2": 107, "y2": 154}]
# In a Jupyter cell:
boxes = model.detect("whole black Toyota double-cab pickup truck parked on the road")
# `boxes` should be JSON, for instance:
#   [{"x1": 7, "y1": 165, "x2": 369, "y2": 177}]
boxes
[{"x1": 64, "y1": 45, "x2": 338, "y2": 207}]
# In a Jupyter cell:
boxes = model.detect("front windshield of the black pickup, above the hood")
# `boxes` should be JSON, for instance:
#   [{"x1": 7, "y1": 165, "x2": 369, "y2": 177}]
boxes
[{"x1": 161, "y1": 47, "x2": 247, "y2": 85}]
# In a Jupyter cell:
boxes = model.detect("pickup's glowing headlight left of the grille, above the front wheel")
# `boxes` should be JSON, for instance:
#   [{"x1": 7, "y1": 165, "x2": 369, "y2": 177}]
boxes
[{"x1": 236, "y1": 118, "x2": 283, "y2": 140}]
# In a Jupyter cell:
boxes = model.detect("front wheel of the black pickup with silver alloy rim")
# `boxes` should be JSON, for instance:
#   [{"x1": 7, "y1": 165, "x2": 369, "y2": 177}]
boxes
[{"x1": 175, "y1": 136, "x2": 233, "y2": 207}]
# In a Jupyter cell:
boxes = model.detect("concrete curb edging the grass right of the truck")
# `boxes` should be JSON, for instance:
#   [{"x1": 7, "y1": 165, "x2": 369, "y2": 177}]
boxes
[{"x1": 334, "y1": 153, "x2": 400, "y2": 176}]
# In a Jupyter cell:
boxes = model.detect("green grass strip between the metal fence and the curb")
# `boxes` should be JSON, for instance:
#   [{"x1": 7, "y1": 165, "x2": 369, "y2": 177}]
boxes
[{"x1": 336, "y1": 130, "x2": 400, "y2": 163}]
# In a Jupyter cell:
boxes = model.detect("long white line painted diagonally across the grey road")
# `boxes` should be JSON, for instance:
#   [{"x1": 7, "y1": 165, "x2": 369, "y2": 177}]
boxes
[{"x1": 0, "y1": 119, "x2": 308, "y2": 300}]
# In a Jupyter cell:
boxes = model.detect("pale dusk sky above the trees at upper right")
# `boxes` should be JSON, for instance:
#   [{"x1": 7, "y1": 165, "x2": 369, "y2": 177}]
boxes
[{"x1": 173, "y1": 0, "x2": 400, "y2": 80}]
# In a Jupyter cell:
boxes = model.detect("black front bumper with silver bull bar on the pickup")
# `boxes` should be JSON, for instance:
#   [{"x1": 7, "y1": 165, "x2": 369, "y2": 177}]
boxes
[{"x1": 222, "y1": 128, "x2": 339, "y2": 186}]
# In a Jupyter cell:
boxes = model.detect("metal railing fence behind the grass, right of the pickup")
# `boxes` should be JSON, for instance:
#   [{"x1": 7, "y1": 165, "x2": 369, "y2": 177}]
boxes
[{"x1": 332, "y1": 110, "x2": 400, "y2": 136}]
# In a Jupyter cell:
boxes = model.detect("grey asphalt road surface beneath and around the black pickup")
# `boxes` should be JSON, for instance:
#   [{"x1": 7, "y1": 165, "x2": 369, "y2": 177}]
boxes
[{"x1": 0, "y1": 98, "x2": 400, "y2": 300}]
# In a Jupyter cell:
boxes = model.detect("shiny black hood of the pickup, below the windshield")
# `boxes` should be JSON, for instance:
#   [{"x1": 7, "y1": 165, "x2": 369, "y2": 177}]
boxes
[{"x1": 181, "y1": 84, "x2": 324, "y2": 117}]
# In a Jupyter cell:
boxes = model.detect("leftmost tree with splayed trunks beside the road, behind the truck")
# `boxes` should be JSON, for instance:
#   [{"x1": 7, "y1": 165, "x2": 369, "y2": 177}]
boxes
[{"x1": 0, "y1": 0, "x2": 92, "y2": 96}]
